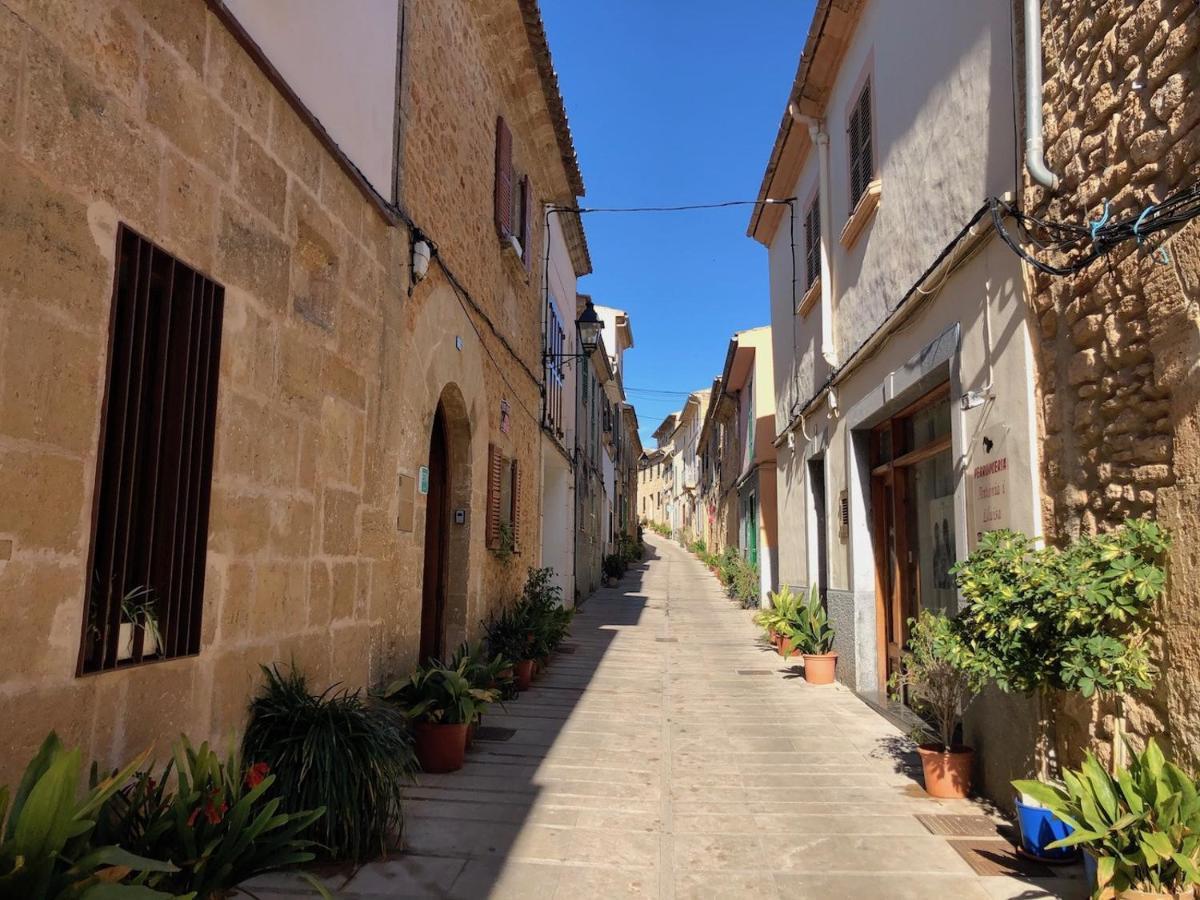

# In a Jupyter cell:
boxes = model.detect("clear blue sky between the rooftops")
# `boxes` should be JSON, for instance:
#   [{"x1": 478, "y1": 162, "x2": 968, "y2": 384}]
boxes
[{"x1": 541, "y1": 0, "x2": 812, "y2": 446}]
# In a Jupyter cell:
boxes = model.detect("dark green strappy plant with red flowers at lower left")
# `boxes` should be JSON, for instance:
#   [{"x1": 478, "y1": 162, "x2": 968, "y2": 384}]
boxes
[{"x1": 94, "y1": 737, "x2": 325, "y2": 900}]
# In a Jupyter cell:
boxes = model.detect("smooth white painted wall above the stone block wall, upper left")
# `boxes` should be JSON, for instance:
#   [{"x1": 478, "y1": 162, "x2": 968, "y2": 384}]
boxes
[{"x1": 226, "y1": 0, "x2": 400, "y2": 200}]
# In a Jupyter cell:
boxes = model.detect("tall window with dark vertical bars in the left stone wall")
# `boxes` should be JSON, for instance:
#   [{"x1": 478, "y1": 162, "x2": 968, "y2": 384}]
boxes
[{"x1": 78, "y1": 226, "x2": 224, "y2": 674}]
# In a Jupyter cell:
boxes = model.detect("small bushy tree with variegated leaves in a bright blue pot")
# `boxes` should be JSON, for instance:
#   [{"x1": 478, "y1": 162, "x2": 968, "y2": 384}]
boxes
[{"x1": 950, "y1": 520, "x2": 1170, "y2": 862}]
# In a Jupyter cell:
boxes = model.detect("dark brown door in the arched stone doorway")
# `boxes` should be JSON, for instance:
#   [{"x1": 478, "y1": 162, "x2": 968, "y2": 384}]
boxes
[{"x1": 421, "y1": 403, "x2": 451, "y2": 665}]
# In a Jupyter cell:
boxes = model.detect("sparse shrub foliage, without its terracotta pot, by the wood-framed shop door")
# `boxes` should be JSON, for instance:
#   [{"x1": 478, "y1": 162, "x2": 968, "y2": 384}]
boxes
[{"x1": 888, "y1": 610, "x2": 982, "y2": 750}]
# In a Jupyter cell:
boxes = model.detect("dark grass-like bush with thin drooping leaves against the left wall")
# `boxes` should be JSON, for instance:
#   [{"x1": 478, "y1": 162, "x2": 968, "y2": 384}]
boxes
[{"x1": 242, "y1": 666, "x2": 416, "y2": 862}]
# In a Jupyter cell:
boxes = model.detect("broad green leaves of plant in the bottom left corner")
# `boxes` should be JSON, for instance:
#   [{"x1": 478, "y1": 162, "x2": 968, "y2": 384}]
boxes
[{"x1": 0, "y1": 732, "x2": 175, "y2": 900}]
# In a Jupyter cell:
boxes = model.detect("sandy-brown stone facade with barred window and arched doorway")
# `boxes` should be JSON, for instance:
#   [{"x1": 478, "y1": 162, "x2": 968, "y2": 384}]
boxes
[{"x1": 0, "y1": 0, "x2": 583, "y2": 782}]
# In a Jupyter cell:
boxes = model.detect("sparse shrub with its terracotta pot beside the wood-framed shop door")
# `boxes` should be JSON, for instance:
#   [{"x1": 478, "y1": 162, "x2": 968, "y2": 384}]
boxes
[{"x1": 889, "y1": 610, "x2": 979, "y2": 799}]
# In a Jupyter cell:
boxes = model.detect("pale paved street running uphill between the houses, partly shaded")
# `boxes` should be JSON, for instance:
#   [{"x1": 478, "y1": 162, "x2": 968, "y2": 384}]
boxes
[{"x1": 254, "y1": 536, "x2": 1082, "y2": 900}]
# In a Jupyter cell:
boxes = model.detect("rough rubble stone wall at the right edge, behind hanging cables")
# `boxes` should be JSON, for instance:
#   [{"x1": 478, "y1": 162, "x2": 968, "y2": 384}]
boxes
[{"x1": 1025, "y1": 0, "x2": 1200, "y2": 762}]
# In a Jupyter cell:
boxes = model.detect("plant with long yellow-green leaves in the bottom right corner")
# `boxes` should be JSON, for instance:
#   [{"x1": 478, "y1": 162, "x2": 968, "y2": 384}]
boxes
[{"x1": 1013, "y1": 738, "x2": 1200, "y2": 900}]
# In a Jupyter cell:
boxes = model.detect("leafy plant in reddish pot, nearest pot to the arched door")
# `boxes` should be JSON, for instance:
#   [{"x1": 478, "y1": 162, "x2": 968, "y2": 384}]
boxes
[{"x1": 383, "y1": 662, "x2": 498, "y2": 773}]
